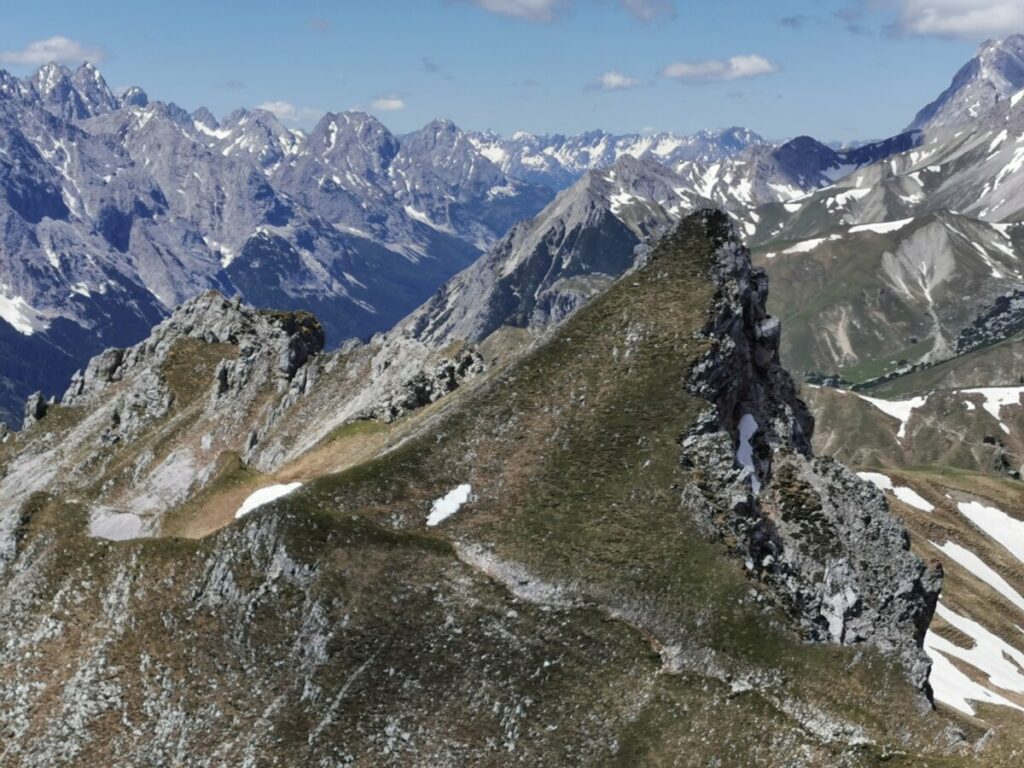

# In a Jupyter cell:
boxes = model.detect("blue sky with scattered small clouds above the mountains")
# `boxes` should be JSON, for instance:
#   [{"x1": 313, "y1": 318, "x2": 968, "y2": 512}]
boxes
[{"x1": 0, "y1": 0, "x2": 1024, "y2": 140}]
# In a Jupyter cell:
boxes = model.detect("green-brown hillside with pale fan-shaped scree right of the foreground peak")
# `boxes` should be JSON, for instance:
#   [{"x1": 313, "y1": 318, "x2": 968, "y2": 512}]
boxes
[{"x1": 756, "y1": 210, "x2": 1024, "y2": 385}]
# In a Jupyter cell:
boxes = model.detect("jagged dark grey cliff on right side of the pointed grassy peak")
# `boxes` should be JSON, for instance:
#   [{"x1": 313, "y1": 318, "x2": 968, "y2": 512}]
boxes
[{"x1": 683, "y1": 212, "x2": 941, "y2": 687}]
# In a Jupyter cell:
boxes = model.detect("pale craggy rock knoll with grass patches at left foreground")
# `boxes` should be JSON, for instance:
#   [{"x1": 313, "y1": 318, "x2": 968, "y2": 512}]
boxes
[{"x1": 0, "y1": 292, "x2": 325, "y2": 562}]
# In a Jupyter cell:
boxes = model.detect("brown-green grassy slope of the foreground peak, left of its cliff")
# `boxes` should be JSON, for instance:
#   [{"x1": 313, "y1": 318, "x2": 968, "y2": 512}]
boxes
[{"x1": 0, "y1": 214, "x2": 1017, "y2": 766}]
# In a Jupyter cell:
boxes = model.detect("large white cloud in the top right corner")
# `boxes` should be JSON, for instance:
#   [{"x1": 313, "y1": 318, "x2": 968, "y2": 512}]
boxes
[{"x1": 895, "y1": 0, "x2": 1024, "y2": 40}]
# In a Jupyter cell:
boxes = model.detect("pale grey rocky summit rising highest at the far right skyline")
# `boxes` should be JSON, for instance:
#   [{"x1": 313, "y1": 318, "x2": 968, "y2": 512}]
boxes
[{"x1": 909, "y1": 35, "x2": 1024, "y2": 130}]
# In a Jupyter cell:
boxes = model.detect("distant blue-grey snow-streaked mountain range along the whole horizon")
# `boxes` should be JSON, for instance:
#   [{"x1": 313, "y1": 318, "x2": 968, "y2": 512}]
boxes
[{"x1": 0, "y1": 31, "x2": 1022, "y2": 424}]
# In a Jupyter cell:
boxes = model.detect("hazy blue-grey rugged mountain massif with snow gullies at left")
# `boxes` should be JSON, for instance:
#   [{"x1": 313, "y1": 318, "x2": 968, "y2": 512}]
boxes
[{"x1": 0, "y1": 65, "x2": 550, "y2": 428}]
